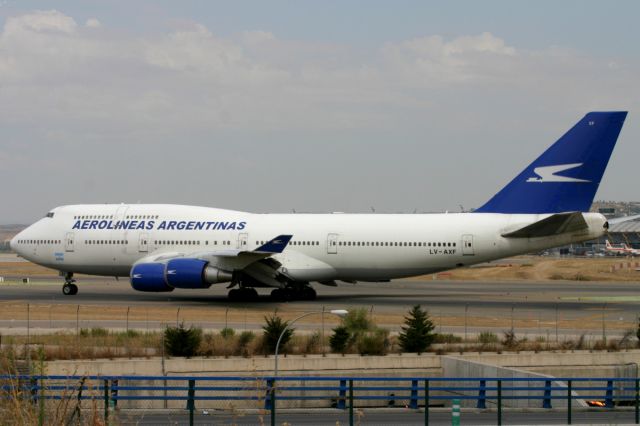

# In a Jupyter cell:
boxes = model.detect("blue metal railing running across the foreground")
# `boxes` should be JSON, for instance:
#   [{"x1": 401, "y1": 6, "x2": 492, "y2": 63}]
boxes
[{"x1": 0, "y1": 375, "x2": 640, "y2": 425}]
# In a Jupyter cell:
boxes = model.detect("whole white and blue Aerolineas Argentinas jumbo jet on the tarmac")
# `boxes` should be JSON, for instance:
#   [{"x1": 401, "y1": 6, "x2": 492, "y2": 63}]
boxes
[{"x1": 10, "y1": 111, "x2": 627, "y2": 301}]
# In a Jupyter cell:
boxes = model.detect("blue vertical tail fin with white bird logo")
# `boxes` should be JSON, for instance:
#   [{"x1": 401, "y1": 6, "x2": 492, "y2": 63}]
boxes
[{"x1": 476, "y1": 111, "x2": 627, "y2": 213}]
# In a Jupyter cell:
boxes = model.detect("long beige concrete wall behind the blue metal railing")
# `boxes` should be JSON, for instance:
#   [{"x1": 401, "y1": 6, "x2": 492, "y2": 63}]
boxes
[{"x1": 46, "y1": 350, "x2": 640, "y2": 410}]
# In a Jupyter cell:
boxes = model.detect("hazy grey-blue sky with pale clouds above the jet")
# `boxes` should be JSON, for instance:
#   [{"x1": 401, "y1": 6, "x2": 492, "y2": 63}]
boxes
[{"x1": 0, "y1": 0, "x2": 640, "y2": 223}]
